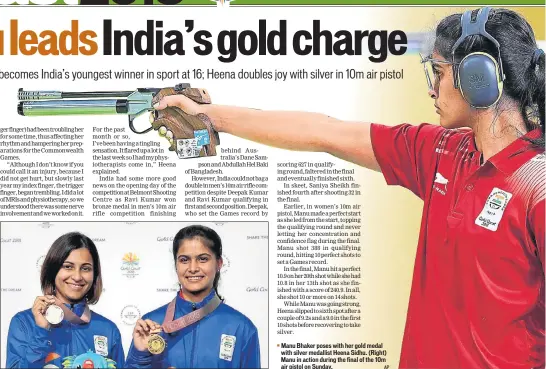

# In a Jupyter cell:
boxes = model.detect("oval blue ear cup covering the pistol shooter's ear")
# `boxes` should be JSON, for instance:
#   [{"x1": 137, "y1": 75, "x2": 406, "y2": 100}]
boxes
[{"x1": 456, "y1": 53, "x2": 503, "y2": 108}]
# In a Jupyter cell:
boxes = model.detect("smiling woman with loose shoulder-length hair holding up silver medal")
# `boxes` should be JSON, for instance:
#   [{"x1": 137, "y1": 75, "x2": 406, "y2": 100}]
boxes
[{"x1": 6, "y1": 233, "x2": 125, "y2": 368}]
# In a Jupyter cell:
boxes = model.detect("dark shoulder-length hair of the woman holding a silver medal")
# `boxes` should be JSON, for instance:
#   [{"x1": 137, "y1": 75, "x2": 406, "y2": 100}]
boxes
[{"x1": 40, "y1": 232, "x2": 102, "y2": 305}]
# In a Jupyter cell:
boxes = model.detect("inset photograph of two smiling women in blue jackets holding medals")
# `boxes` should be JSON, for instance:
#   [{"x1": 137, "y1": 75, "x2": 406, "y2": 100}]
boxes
[{"x1": 0, "y1": 222, "x2": 269, "y2": 368}]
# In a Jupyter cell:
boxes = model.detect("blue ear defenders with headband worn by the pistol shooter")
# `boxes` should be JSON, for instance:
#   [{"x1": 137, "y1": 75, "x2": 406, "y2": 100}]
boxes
[{"x1": 451, "y1": 7, "x2": 504, "y2": 109}]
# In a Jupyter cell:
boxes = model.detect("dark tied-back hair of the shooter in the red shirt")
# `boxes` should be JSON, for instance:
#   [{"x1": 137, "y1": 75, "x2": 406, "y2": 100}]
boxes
[{"x1": 434, "y1": 8, "x2": 545, "y2": 146}]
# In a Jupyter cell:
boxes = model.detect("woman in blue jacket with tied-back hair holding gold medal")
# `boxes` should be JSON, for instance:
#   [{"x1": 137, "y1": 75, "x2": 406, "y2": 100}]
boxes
[{"x1": 126, "y1": 225, "x2": 260, "y2": 368}]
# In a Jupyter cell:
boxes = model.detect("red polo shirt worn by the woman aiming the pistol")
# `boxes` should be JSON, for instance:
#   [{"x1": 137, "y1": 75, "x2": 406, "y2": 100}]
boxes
[{"x1": 371, "y1": 124, "x2": 546, "y2": 369}]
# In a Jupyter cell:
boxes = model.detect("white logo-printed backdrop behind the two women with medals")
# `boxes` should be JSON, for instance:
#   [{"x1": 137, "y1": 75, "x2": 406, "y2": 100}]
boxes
[{"x1": 0, "y1": 222, "x2": 268, "y2": 367}]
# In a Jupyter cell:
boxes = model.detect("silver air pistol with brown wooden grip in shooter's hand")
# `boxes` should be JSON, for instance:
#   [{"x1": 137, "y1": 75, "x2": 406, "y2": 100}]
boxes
[{"x1": 17, "y1": 83, "x2": 220, "y2": 158}]
